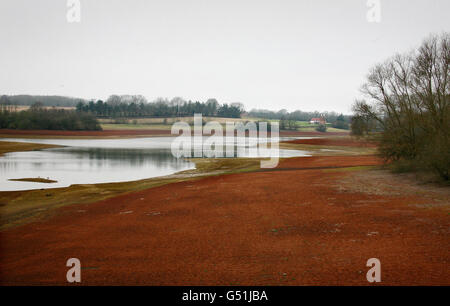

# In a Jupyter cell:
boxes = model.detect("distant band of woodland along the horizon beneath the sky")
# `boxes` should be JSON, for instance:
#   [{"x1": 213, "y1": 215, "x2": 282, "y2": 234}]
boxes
[{"x1": 0, "y1": 95, "x2": 351, "y2": 130}]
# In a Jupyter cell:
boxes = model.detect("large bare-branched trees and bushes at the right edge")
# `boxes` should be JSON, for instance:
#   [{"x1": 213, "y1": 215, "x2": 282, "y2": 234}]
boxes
[{"x1": 352, "y1": 33, "x2": 450, "y2": 181}]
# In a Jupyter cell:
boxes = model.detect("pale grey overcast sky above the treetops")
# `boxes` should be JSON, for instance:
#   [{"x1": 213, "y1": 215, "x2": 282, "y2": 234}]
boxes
[{"x1": 0, "y1": 0, "x2": 450, "y2": 113}]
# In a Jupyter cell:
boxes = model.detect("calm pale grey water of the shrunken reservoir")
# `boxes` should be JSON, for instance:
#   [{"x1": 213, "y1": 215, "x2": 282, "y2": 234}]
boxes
[{"x1": 0, "y1": 137, "x2": 307, "y2": 191}]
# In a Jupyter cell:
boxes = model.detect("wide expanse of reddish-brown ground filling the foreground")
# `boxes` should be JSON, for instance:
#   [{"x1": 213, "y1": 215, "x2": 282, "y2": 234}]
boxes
[{"x1": 0, "y1": 136, "x2": 450, "y2": 285}]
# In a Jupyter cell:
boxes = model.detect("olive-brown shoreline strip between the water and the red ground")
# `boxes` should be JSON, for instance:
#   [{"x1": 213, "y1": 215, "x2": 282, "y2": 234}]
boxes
[{"x1": 0, "y1": 136, "x2": 370, "y2": 231}]
